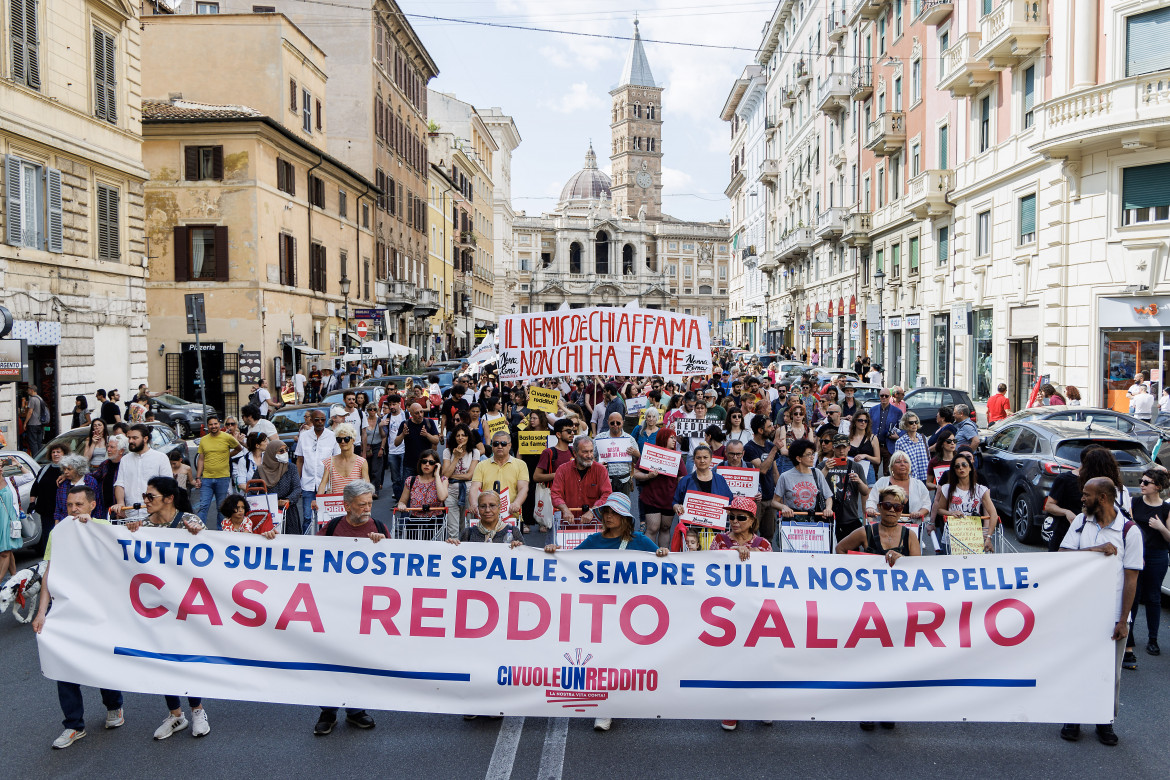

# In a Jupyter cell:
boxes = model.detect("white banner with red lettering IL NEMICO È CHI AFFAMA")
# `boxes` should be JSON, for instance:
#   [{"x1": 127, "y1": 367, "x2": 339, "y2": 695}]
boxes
[{"x1": 497, "y1": 306, "x2": 711, "y2": 380}]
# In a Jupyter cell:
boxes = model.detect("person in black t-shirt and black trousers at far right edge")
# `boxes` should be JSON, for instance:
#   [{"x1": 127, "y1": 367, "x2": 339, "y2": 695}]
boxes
[{"x1": 1126, "y1": 468, "x2": 1170, "y2": 655}]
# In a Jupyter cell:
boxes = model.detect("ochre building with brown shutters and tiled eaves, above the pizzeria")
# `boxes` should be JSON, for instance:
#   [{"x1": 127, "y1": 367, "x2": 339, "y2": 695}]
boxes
[{"x1": 143, "y1": 14, "x2": 380, "y2": 414}]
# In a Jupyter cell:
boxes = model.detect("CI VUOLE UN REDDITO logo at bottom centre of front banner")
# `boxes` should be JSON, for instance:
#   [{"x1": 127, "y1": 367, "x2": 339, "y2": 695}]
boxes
[{"x1": 496, "y1": 648, "x2": 659, "y2": 712}]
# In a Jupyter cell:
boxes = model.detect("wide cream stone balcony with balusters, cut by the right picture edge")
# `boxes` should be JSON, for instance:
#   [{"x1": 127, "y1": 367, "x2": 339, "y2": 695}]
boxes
[{"x1": 1031, "y1": 73, "x2": 1170, "y2": 158}]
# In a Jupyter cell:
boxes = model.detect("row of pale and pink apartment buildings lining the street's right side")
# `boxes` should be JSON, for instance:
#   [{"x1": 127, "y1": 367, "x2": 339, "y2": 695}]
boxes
[{"x1": 725, "y1": 0, "x2": 1170, "y2": 408}]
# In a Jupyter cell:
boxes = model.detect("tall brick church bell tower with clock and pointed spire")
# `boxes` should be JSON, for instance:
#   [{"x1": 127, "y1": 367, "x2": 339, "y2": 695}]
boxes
[{"x1": 610, "y1": 20, "x2": 662, "y2": 220}]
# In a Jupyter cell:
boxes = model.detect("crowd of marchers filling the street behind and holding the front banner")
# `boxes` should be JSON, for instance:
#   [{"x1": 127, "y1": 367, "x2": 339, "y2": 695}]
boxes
[{"x1": 16, "y1": 348, "x2": 1151, "y2": 747}]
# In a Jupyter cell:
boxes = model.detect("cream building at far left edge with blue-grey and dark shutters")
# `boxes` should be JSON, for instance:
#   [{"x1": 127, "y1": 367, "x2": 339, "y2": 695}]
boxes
[{"x1": 0, "y1": 0, "x2": 149, "y2": 448}]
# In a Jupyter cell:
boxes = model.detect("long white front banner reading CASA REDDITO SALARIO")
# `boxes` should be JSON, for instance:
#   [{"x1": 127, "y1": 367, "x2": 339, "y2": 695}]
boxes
[{"x1": 40, "y1": 522, "x2": 1120, "y2": 723}]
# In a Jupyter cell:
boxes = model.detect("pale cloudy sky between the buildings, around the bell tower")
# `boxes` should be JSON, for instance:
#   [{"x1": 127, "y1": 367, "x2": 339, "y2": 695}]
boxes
[{"x1": 399, "y1": 0, "x2": 776, "y2": 220}]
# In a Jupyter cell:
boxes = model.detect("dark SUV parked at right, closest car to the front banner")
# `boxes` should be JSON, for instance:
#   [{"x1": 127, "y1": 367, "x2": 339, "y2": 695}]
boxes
[{"x1": 979, "y1": 419, "x2": 1154, "y2": 544}]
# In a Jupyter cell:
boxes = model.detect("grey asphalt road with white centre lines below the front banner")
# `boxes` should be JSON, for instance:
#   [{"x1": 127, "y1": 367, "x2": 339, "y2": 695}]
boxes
[{"x1": 0, "y1": 496, "x2": 1170, "y2": 780}]
